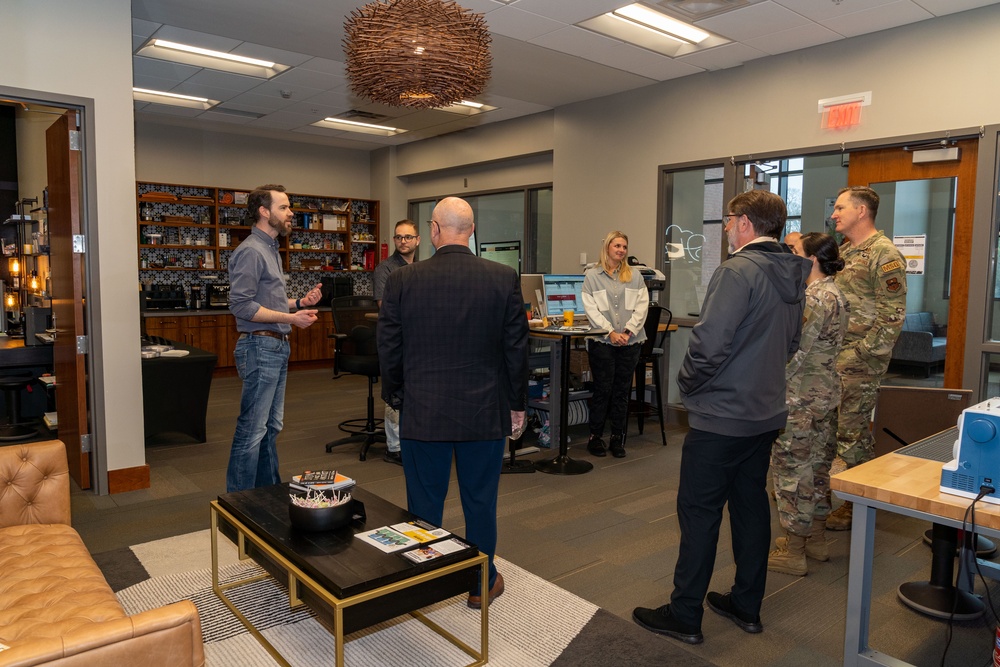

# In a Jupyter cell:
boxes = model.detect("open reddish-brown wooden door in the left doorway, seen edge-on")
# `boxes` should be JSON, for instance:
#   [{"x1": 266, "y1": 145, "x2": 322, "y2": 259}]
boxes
[{"x1": 45, "y1": 111, "x2": 91, "y2": 489}]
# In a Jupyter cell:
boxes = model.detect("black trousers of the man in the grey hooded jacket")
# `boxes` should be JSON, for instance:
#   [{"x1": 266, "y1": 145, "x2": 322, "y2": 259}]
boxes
[{"x1": 670, "y1": 429, "x2": 778, "y2": 628}]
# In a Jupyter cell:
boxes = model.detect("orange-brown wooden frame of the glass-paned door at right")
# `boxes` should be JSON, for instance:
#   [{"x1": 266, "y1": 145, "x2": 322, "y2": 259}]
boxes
[{"x1": 847, "y1": 139, "x2": 979, "y2": 388}]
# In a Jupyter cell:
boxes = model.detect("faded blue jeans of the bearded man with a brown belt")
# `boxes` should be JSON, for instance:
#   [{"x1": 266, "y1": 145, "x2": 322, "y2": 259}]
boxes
[{"x1": 226, "y1": 336, "x2": 290, "y2": 492}]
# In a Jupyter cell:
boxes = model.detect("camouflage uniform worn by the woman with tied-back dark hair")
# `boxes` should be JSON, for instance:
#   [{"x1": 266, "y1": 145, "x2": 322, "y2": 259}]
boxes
[{"x1": 771, "y1": 276, "x2": 850, "y2": 536}]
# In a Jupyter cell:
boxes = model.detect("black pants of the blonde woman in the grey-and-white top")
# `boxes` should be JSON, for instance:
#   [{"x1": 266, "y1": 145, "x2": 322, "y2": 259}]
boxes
[{"x1": 587, "y1": 341, "x2": 642, "y2": 437}]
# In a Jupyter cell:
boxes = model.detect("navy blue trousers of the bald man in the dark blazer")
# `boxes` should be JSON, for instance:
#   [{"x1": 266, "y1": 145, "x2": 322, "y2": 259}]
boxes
[{"x1": 400, "y1": 438, "x2": 506, "y2": 595}]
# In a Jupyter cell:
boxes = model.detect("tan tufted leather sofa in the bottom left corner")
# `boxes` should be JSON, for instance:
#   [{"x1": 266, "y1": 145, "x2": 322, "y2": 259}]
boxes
[{"x1": 0, "y1": 440, "x2": 205, "y2": 667}]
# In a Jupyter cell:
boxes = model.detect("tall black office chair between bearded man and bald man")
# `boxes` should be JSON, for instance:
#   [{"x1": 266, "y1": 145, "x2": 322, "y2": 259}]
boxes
[{"x1": 326, "y1": 296, "x2": 385, "y2": 461}]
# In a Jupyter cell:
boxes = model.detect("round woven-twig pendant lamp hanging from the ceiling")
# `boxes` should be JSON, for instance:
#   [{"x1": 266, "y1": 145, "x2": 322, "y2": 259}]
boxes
[{"x1": 344, "y1": 0, "x2": 492, "y2": 109}]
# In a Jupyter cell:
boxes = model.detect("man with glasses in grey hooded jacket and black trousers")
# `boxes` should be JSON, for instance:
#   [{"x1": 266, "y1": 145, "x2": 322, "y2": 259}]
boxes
[{"x1": 632, "y1": 190, "x2": 810, "y2": 644}]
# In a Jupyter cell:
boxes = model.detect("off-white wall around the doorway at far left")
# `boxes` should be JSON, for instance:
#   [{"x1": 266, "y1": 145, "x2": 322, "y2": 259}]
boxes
[{"x1": 0, "y1": 0, "x2": 145, "y2": 480}]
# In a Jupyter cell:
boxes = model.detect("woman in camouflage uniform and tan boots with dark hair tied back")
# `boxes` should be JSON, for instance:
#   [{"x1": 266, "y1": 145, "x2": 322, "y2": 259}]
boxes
[{"x1": 767, "y1": 233, "x2": 850, "y2": 576}]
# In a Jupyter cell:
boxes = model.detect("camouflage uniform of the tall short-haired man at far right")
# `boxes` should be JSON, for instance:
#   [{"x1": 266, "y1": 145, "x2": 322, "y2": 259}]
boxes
[{"x1": 836, "y1": 232, "x2": 906, "y2": 468}]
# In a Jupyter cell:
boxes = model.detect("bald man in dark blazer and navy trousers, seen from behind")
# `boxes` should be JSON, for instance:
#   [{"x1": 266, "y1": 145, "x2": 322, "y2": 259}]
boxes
[{"x1": 377, "y1": 197, "x2": 528, "y2": 609}]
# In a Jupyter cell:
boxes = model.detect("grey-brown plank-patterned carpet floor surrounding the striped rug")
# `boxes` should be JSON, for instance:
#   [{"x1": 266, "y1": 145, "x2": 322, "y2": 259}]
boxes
[{"x1": 72, "y1": 369, "x2": 1000, "y2": 667}]
